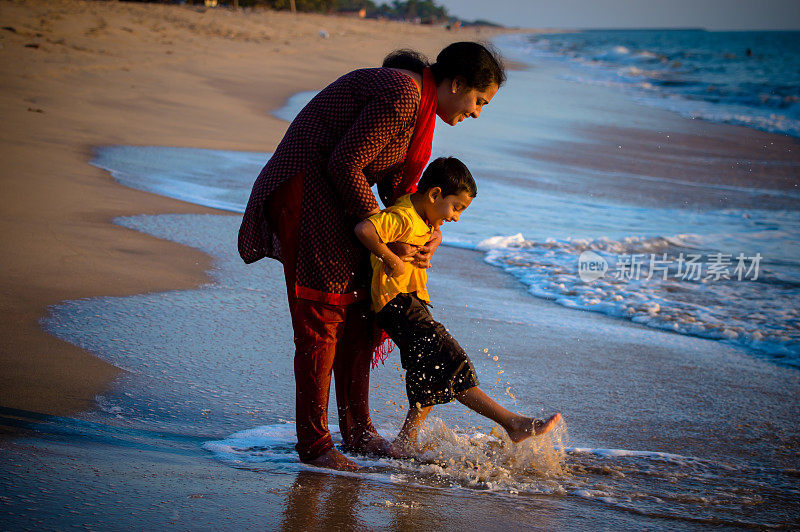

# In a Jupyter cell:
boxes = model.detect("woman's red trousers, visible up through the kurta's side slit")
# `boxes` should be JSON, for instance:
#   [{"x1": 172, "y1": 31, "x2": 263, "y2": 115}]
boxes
[{"x1": 269, "y1": 174, "x2": 378, "y2": 462}]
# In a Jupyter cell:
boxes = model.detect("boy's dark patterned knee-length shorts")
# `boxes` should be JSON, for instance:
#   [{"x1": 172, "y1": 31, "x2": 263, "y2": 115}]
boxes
[{"x1": 377, "y1": 293, "x2": 478, "y2": 407}]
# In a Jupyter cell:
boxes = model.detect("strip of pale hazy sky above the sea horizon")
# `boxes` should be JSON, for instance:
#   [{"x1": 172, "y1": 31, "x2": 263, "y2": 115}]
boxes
[{"x1": 436, "y1": 0, "x2": 800, "y2": 30}]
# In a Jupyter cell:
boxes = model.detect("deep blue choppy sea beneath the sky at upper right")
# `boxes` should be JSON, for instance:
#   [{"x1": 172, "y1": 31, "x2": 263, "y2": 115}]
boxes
[{"x1": 506, "y1": 29, "x2": 800, "y2": 137}]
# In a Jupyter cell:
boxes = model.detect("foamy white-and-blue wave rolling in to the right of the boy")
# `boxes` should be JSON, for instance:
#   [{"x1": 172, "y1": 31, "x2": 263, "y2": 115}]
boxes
[{"x1": 477, "y1": 234, "x2": 800, "y2": 367}]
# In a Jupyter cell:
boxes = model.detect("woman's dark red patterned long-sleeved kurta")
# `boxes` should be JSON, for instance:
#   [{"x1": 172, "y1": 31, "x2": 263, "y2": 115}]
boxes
[{"x1": 239, "y1": 68, "x2": 420, "y2": 304}]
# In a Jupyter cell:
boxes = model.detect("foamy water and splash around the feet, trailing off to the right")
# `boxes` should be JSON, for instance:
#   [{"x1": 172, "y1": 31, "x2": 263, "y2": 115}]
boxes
[{"x1": 203, "y1": 417, "x2": 761, "y2": 519}]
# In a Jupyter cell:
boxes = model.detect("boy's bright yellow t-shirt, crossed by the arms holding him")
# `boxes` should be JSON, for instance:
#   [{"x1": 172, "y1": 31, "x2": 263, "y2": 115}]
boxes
[{"x1": 369, "y1": 195, "x2": 433, "y2": 312}]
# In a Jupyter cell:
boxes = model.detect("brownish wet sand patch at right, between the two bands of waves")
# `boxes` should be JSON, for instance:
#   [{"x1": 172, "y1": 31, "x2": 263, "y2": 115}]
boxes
[{"x1": 527, "y1": 119, "x2": 800, "y2": 210}]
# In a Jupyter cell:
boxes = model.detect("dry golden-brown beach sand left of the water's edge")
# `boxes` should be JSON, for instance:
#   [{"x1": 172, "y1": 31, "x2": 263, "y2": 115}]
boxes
[{"x1": 0, "y1": 0, "x2": 512, "y2": 420}]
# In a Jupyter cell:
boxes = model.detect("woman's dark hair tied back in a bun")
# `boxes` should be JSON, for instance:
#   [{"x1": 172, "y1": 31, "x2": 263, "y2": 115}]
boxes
[{"x1": 383, "y1": 41, "x2": 506, "y2": 90}]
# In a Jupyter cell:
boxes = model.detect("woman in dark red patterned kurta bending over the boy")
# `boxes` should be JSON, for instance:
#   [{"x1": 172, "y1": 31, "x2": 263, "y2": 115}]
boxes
[{"x1": 234, "y1": 42, "x2": 505, "y2": 469}]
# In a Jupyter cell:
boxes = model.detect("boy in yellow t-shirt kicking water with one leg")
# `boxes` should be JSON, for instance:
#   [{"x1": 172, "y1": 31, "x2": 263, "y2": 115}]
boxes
[{"x1": 355, "y1": 157, "x2": 561, "y2": 457}]
